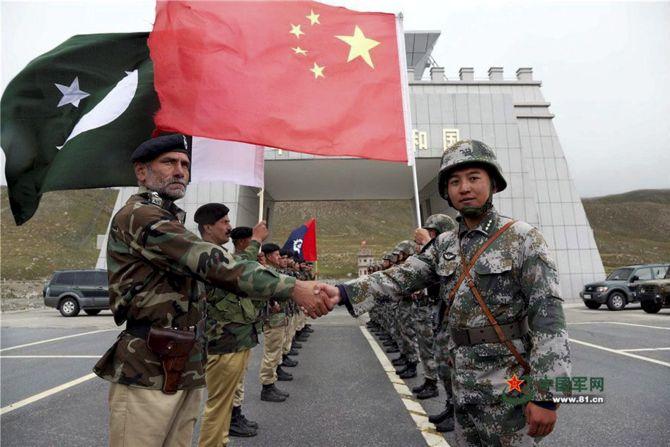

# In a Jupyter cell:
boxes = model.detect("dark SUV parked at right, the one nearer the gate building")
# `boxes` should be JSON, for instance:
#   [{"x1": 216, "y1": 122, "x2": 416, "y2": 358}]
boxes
[{"x1": 579, "y1": 264, "x2": 669, "y2": 310}]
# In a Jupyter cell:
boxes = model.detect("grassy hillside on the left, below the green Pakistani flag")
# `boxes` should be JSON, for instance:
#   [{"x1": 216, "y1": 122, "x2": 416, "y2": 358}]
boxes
[{"x1": 0, "y1": 187, "x2": 117, "y2": 280}]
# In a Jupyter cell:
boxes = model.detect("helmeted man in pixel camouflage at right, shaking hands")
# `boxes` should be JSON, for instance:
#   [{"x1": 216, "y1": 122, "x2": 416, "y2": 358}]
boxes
[{"x1": 319, "y1": 140, "x2": 571, "y2": 446}]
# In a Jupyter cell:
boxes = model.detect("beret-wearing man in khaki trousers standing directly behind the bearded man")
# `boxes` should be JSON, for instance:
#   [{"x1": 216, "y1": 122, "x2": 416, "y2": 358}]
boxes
[{"x1": 193, "y1": 212, "x2": 268, "y2": 447}]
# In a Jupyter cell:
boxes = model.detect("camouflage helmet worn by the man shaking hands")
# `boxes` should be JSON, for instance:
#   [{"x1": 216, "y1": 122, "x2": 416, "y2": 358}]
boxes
[{"x1": 438, "y1": 140, "x2": 507, "y2": 200}]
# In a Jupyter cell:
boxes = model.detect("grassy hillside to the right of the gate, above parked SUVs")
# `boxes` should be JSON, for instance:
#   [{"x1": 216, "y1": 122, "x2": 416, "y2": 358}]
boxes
[{"x1": 582, "y1": 189, "x2": 670, "y2": 271}]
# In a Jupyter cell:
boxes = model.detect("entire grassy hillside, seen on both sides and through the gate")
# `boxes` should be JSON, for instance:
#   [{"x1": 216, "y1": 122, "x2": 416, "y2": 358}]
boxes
[{"x1": 0, "y1": 187, "x2": 670, "y2": 280}]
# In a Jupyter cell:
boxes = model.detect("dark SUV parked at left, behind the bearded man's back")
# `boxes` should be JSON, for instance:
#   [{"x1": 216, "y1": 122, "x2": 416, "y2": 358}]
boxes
[{"x1": 42, "y1": 270, "x2": 109, "y2": 317}]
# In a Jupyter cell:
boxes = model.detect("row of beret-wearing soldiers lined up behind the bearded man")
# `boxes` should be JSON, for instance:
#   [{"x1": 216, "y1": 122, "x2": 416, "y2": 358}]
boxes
[{"x1": 194, "y1": 203, "x2": 315, "y2": 447}]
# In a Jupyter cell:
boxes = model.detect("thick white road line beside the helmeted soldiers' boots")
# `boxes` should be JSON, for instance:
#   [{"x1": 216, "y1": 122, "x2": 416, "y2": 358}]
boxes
[{"x1": 359, "y1": 326, "x2": 450, "y2": 447}]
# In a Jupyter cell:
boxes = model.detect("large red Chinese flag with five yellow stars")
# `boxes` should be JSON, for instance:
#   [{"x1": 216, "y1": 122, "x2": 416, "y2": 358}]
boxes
[{"x1": 149, "y1": 1, "x2": 408, "y2": 161}]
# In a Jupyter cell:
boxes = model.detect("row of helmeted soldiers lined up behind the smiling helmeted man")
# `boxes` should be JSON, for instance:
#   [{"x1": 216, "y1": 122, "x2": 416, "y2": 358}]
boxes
[{"x1": 367, "y1": 214, "x2": 457, "y2": 432}]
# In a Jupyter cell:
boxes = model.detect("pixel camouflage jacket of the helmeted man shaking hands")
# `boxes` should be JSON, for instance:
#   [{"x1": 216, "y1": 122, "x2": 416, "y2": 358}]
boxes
[{"x1": 344, "y1": 210, "x2": 571, "y2": 404}]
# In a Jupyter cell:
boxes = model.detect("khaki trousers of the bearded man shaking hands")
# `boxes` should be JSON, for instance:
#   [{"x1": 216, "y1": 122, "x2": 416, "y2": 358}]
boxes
[{"x1": 109, "y1": 383, "x2": 204, "y2": 447}]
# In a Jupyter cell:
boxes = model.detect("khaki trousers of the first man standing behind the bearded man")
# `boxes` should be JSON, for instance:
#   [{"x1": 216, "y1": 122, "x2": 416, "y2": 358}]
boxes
[{"x1": 198, "y1": 349, "x2": 251, "y2": 447}]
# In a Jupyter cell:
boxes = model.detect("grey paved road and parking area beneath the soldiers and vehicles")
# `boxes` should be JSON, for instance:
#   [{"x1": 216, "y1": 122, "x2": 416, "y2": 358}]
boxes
[{"x1": 0, "y1": 306, "x2": 670, "y2": 447}]
